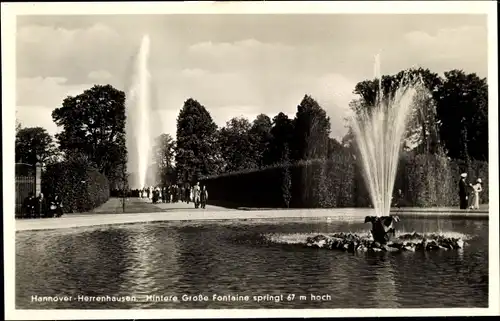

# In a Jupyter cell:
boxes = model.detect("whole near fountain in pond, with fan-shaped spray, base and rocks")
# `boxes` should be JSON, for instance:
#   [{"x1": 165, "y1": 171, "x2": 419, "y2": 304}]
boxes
[{"x1": 264, "y1": 57, "x2": 464, "y2": 252}]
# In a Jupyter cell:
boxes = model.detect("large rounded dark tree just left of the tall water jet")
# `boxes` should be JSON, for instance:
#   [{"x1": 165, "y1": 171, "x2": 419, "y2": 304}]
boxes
[{"x1": 52, "y1": 85, "x2": 126, "y2": 182}]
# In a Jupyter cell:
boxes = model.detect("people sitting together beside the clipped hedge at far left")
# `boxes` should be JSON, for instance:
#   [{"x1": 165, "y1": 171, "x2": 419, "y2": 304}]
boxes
[{"x1": 22, "y1": 193, "x2": 63, "y2": 218}]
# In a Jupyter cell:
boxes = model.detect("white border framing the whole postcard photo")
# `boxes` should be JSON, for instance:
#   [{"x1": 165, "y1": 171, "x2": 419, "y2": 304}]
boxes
[{"x1": 1, "y1": 1, "x2": 500, "y2": 320}]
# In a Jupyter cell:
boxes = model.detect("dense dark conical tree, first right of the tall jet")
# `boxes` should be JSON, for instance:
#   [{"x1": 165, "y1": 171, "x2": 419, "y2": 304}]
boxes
[{"x1": 175, "y1": 98, "x2": 220, "y2": 182}]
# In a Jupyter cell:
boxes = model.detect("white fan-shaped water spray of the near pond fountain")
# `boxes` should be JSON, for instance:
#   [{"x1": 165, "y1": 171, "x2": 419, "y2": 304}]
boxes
[{"x1": 352, "y1": 56, "x2": 418, "y2": 217}]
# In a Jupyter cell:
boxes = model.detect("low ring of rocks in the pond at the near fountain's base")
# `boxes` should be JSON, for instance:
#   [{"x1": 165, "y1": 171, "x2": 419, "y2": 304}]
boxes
[{"x1": 305, "y1": 233, "x2": 464, "y2": 253}]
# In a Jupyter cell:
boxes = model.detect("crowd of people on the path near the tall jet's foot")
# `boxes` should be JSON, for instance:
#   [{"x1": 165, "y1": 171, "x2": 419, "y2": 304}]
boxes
[{"x1": 139, "y1": 182, "x2": 208, "y2": 208}]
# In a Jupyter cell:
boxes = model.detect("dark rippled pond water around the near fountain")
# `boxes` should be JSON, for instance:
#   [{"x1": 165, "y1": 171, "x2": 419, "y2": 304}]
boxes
[{"x1": 16, "y1": 217, "x2": 488, "y2": 309}]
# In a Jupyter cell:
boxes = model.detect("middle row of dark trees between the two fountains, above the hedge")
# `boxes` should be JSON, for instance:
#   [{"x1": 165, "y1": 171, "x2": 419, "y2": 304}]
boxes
[{"x1": 175, "y1": 95, "x2": 342, "y2": 182}]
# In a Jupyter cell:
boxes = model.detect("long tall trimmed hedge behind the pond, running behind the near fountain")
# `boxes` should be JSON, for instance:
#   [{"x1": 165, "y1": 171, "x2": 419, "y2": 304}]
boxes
[{"x1": 202, "y1": 154, "x2": 488, "y2": 208}]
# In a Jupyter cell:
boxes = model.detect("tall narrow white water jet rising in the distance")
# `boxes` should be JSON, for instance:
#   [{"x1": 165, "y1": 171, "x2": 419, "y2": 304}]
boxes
[{"x1": 126, "y1": 35, "x2": 152, "y2": 188}]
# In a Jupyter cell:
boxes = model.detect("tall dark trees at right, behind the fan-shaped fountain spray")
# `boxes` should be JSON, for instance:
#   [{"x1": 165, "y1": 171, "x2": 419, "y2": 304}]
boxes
[{"x1": 345, "y1": 68, "x2": 488, "y2": 160}]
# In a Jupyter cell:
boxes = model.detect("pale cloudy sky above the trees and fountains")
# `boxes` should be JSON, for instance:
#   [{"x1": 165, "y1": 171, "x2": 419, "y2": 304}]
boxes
[{"x1": 16, "y1": 14, "x2": 488, "y2": 138}]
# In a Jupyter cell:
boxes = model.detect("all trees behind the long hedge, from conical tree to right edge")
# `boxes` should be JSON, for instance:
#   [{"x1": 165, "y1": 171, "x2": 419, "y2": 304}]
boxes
[{"x1": 170, "y1": 69, "x2": 488, "y2": 185}]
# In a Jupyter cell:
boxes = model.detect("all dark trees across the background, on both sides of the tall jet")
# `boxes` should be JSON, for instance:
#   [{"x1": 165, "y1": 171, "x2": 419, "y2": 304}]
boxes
[{"x1": 16, "y1": 69, "x2": 488, "y2": 196}]
